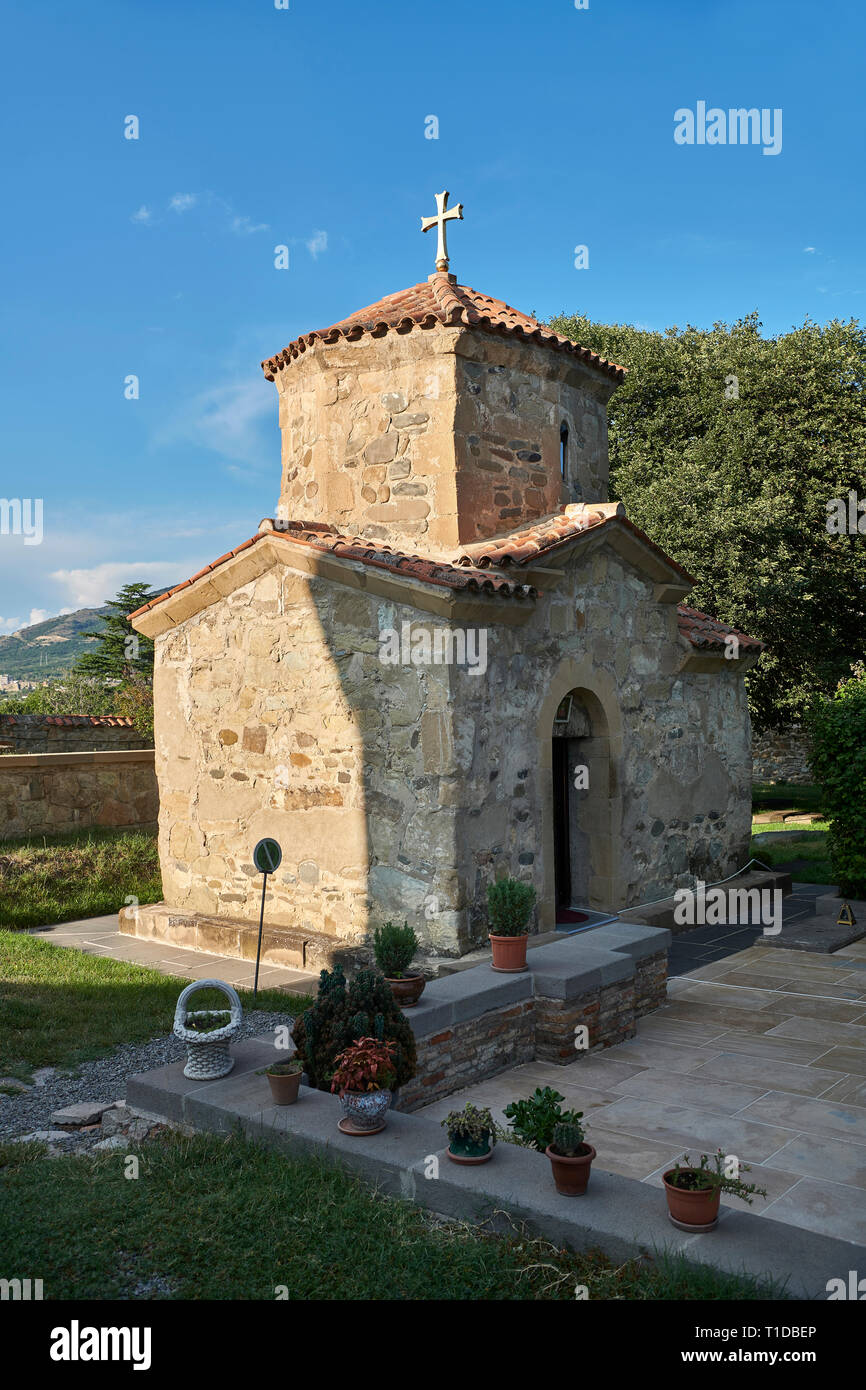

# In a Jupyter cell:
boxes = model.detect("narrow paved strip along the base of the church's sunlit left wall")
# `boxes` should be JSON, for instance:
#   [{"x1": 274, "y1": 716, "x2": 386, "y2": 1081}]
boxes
[{"x1": 31, "y1": 913, "x2": 318, "y2": 994}]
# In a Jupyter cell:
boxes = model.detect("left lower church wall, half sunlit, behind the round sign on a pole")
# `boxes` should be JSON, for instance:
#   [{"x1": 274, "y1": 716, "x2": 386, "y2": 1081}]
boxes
[{"x1": 148, "y1": 558, "x2": 471, "y2": 951}]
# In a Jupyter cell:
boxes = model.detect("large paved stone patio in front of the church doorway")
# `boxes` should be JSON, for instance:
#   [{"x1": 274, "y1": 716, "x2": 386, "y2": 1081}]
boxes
[{"x1": 418, "y1": 942, "x2": 866, "y2": 1245}]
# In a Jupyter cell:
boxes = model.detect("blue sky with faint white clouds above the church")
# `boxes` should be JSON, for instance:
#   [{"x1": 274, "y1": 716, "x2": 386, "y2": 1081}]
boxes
[{"x1": 0, "y1": 0, "x2": 866, "y2": 632}]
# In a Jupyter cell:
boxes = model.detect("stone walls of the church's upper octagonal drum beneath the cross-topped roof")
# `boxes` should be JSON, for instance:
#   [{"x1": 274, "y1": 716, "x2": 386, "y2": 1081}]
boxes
[{"x1": 277, "y1": 327, "x2": 613, "y2": 555}]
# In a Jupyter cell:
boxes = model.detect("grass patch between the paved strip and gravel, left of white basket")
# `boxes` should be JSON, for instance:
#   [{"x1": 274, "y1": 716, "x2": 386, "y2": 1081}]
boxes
[{"x1": 0, "y1": 931, "x2": 310, "y2": 1080}]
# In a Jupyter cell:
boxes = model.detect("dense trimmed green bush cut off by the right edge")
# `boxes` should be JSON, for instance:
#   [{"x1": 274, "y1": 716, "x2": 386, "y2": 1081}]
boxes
[{"x1": 809, "y1": 662, "x2": 866, "y2": 898}]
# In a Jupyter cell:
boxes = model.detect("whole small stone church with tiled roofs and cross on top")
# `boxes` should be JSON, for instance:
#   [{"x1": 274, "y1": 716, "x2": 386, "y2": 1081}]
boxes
[{"x1": 124, "y1": 195, "x2": 760, "y2": 969}]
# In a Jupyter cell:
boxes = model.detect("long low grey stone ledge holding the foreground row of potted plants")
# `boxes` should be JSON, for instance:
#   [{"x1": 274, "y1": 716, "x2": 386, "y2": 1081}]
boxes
[{"x1": 126, "y1": 1040, "x2": 855, "y2": 1298}]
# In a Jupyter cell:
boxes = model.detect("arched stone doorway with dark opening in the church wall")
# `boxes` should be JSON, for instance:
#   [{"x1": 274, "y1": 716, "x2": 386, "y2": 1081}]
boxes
[{"x1": 538, "y1": 663, "x2": 626, "y2": 930}]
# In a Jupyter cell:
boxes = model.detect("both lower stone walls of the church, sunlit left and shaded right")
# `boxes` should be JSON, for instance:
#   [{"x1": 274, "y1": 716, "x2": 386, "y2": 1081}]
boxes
[{"x1": 148, "y1": 549, "x2": 751, "y2": 952}]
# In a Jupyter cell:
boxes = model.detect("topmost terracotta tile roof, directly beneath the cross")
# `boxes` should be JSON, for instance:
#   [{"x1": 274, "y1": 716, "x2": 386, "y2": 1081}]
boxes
[{"x1": 261, "y1": 274, "x2": 626, "y2": 382}]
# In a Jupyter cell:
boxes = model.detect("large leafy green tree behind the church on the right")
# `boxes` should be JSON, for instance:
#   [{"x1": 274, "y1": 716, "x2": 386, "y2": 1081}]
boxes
[{"x1": 550, "y1": 314, "x2": 866, "y2": 728}]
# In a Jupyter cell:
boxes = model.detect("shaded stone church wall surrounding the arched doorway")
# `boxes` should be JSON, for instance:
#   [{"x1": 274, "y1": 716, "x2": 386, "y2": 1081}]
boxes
[{"x1": 439, "y1": 549, "x2": 751, "y2": 942}]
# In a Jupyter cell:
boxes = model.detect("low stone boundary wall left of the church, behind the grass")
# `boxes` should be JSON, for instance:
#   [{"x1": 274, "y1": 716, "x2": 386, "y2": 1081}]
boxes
[{"x1": 0, "y1": 748, "x2": 158, "y2": 838}]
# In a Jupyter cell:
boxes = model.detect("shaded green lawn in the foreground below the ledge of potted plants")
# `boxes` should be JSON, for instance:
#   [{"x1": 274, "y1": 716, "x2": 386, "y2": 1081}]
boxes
[{"x1": 0, "y1": 1134, "x2": 780, "y2": 1302}]
